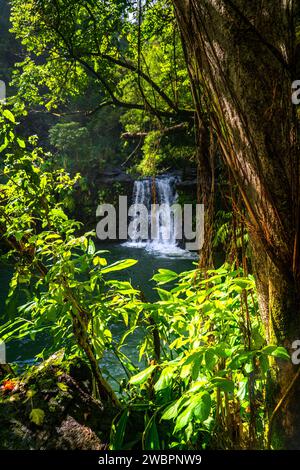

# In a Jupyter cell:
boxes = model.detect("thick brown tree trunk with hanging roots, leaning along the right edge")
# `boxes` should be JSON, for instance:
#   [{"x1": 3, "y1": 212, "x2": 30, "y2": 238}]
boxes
[{"x1": 173, "y1": 0, "x2": 300, "y2": 449}]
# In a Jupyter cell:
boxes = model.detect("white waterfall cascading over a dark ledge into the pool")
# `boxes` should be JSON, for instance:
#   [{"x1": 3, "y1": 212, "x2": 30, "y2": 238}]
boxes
[{"x1": 126, "y1": 176, "x2": 186, "y2": 256}]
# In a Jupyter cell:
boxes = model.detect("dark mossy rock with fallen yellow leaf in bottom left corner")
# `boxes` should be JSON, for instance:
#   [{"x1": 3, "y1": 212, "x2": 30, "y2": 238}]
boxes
[{"x1": 0, "y1": 352, "x2": 116, "y2": 450}]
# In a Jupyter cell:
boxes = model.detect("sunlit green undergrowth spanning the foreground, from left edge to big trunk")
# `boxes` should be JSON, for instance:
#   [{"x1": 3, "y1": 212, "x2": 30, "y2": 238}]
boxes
[{"x1": 0, "y1": 110, "x2": 289, "y2": 449}]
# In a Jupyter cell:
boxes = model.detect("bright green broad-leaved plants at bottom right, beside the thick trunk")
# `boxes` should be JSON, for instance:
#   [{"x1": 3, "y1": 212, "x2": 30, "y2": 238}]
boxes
[{"x1": 114, "y1": 266, "x2": 289, "y2": 449}]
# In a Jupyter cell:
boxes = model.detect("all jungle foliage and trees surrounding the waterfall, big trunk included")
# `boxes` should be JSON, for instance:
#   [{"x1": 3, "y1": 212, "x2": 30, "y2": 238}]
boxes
[{"x1": 0, "y1": 0, "x2": 300, "y2": 449}]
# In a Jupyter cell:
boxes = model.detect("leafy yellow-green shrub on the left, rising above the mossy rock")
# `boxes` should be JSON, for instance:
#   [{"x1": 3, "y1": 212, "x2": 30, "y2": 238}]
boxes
[{"x1": 0, "y1": 109, "x2": 143, "y2": 408}]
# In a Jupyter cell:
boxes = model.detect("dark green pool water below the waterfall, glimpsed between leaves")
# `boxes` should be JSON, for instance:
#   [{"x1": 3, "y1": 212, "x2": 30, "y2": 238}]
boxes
[{"x1": 0, "y1": 243, "x2": 195, "y2": 380}]
